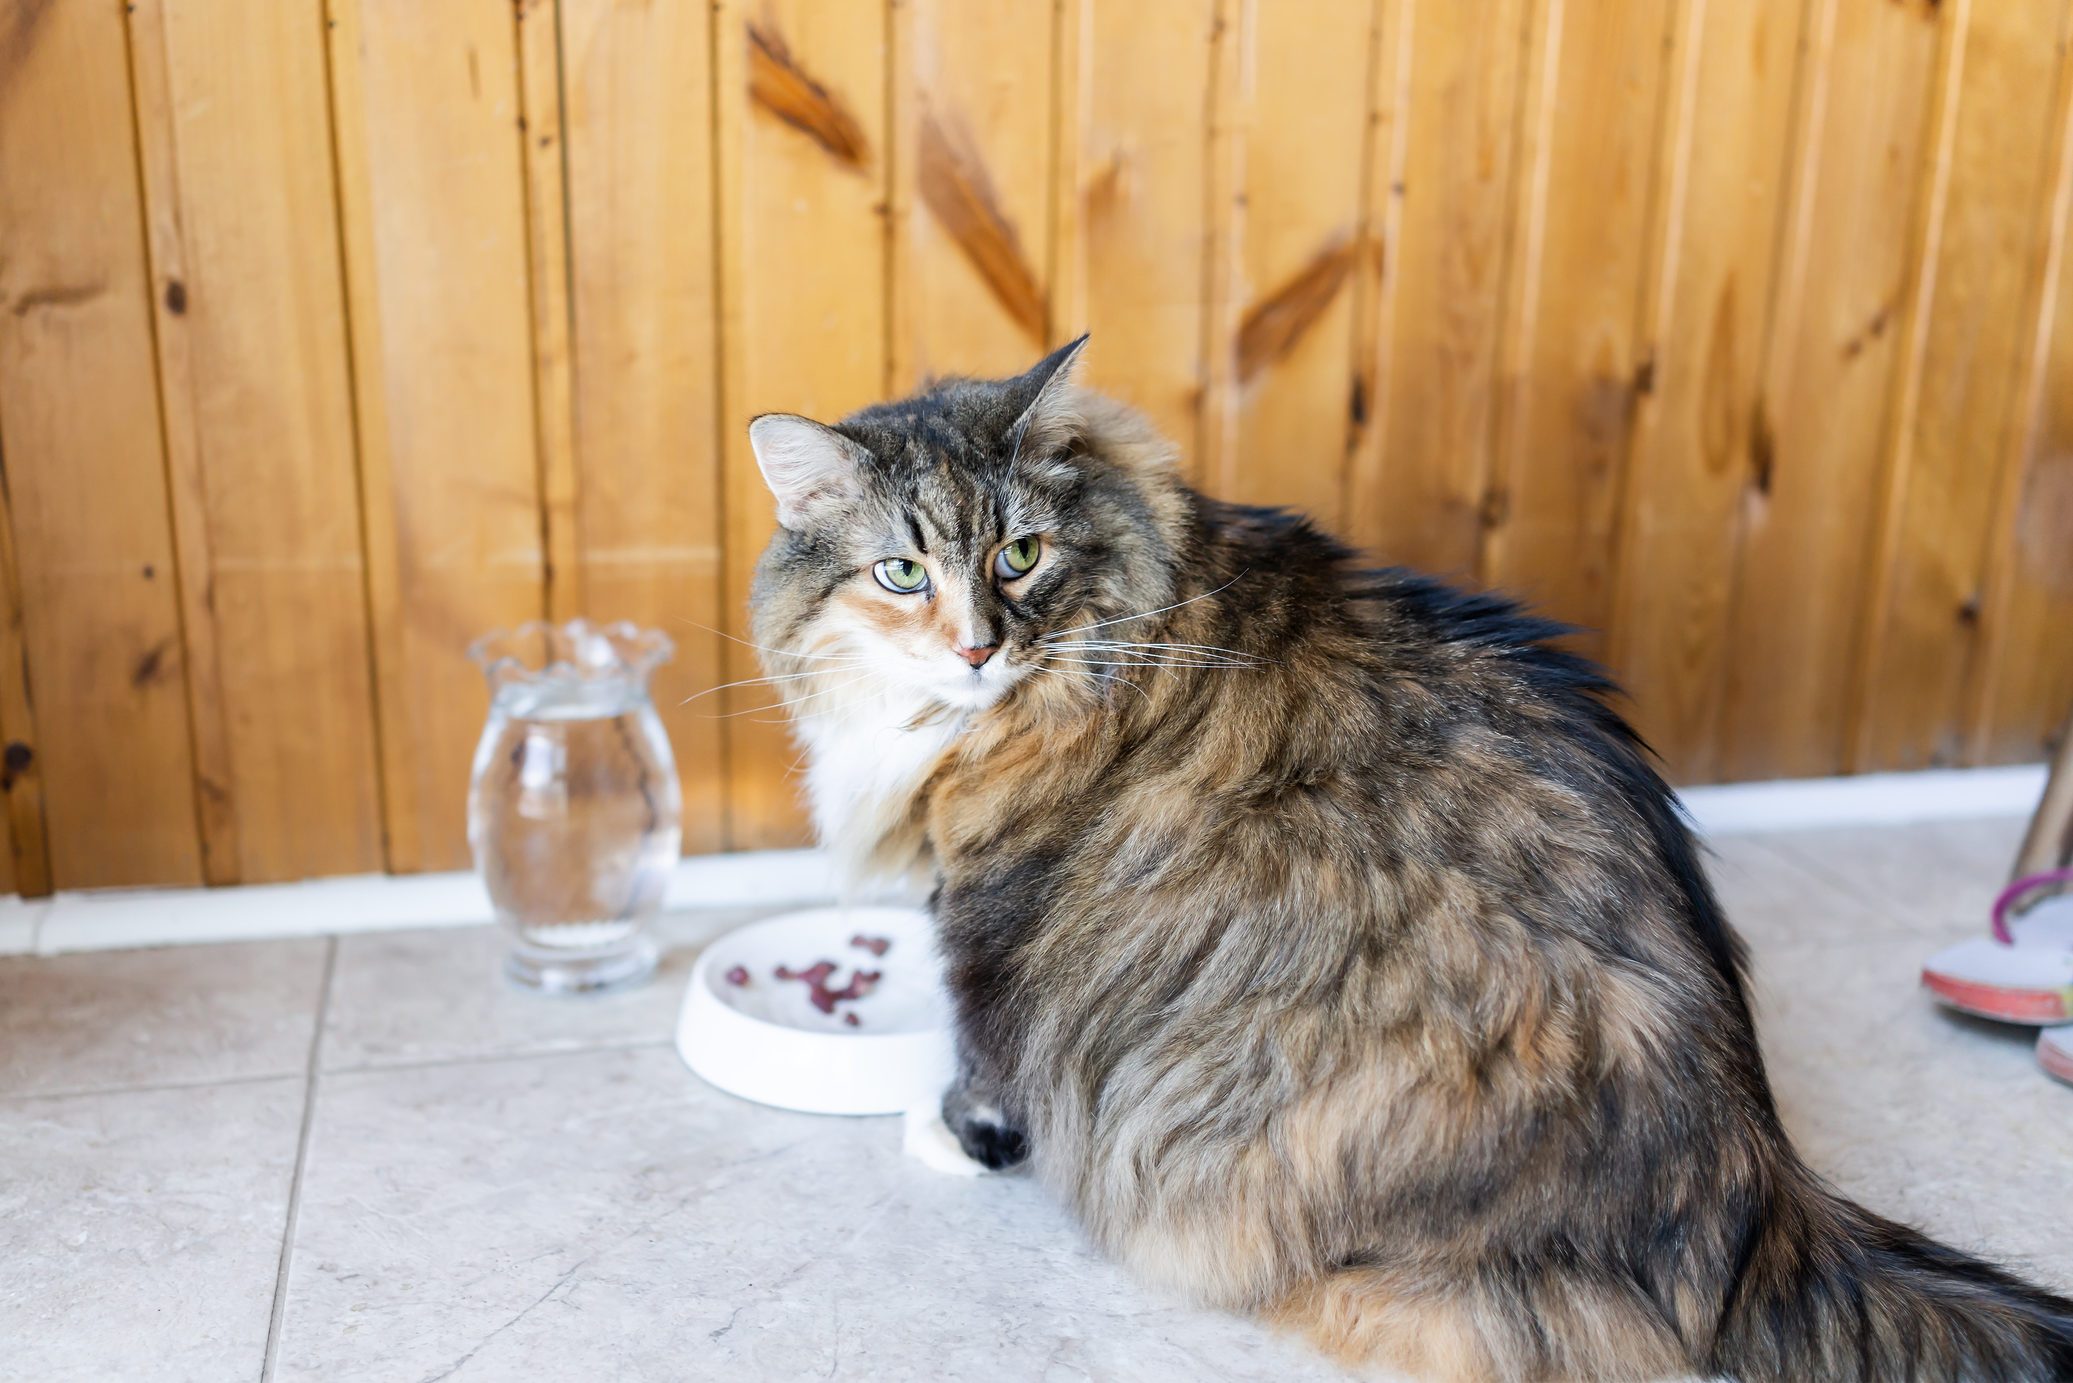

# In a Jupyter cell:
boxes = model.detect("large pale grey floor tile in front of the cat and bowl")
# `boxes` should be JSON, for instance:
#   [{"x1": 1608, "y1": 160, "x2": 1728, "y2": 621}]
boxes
[{"x1": 278, "y1": 1051, "x2": 1339, "y2": 1383}]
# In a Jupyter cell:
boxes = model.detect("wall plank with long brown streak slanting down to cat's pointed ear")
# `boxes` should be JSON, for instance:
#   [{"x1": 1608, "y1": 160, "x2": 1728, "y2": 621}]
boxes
[{"x1": 889, "y1": 0, "x2": 1055, "y2": 394}]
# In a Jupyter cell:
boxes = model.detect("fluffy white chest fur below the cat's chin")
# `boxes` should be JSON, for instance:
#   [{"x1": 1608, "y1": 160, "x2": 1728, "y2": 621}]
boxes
[{"x1": 798, "y1": 697, "x2": 960, "y2": 877}]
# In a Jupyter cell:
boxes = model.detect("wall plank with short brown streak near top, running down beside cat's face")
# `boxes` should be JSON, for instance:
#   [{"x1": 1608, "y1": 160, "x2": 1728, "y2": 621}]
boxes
[{"x1": 713, "y1": 0, "x2": 889, "y2": 848}]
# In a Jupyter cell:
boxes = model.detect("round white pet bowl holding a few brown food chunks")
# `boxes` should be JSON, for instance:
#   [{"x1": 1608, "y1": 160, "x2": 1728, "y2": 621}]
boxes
[{"x1": 676, "y1": 908, "x2": 956, "y2": 1113}]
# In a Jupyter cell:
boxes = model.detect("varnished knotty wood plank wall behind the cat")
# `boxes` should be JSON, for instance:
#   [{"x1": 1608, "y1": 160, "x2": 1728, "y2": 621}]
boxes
[{"x1": 0, "y1": 0, "x2": 2073, "y2": 892}]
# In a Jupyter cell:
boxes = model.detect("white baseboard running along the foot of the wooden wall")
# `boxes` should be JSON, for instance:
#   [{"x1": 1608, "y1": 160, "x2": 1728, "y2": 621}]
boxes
[{"x1": 0, "y1": 765, "x2": 2044, "y2": 956}]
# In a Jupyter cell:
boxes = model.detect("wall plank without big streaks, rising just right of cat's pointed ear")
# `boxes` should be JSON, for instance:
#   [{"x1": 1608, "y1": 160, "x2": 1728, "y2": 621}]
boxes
[{"x1": 1051, "y1": 0, "x2": 1219, "y2": 475}]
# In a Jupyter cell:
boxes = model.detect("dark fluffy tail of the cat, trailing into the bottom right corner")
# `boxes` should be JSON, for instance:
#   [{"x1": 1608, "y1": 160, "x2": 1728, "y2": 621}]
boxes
[{"x1": 1698, "y1": 1178, "x2": 2073, "y2": 1383}]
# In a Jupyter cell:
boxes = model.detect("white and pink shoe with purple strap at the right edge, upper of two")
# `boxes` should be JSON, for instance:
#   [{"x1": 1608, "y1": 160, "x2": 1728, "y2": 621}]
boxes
[{"x1": 1922, "y1": 869, "x2": 2073, "y2": 1028}]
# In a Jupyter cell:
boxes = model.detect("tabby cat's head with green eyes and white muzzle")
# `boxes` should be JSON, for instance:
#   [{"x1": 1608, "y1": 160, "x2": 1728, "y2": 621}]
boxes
[{"x1": 748, "y1": 336, "x2": 1182, "y2": 713}]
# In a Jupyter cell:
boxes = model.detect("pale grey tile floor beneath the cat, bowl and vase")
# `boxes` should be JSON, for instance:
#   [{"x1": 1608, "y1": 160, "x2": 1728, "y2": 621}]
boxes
[{"x1": 0, "y1": 821, "x2": 2073, "y2": 1383}]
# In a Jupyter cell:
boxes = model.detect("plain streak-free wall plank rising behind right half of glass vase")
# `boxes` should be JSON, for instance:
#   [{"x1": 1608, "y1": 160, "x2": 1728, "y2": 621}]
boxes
[{"x1": 559, "y1": 0, "x2": 726, "y2": 852}]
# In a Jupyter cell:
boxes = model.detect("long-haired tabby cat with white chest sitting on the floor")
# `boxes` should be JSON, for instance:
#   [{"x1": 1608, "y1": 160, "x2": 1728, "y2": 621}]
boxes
[{"x1": 750, "y1": 338, "x2": 2073, "y2": 1379}]
